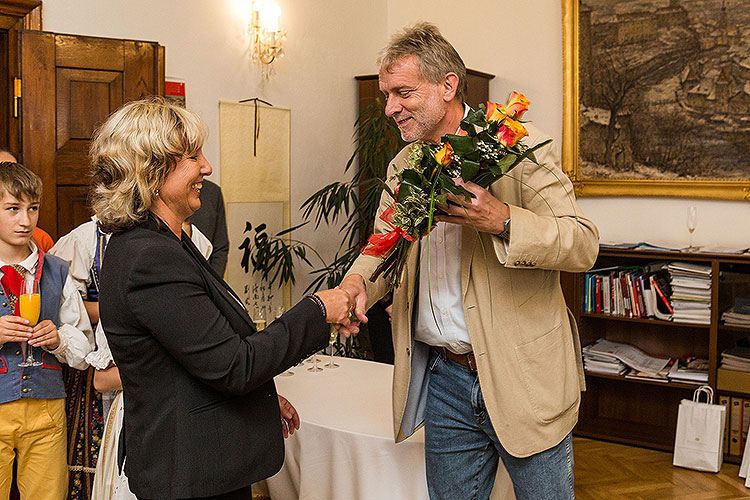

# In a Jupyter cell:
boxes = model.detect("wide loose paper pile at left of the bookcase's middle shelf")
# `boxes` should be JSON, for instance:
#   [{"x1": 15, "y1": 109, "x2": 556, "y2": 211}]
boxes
[{"x1": 583, "y1": 339, "x2": 670, "y2": 375}]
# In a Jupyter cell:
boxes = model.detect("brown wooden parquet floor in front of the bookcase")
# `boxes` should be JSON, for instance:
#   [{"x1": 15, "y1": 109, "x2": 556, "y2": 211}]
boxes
[{"x1": 573, "y1": 438, "x2": 750, "y2": 500}]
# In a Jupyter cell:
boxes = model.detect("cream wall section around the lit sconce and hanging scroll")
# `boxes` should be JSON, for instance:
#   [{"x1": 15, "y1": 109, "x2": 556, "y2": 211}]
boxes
[{"x1": 43, "y1": 0, "x2": 386, "y2": 294}]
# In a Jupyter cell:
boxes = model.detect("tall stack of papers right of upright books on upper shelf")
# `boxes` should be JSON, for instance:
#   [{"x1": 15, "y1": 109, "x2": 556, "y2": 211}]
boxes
[{"x1": 667, "y1": 262, "x2": 711, "y2": 325}]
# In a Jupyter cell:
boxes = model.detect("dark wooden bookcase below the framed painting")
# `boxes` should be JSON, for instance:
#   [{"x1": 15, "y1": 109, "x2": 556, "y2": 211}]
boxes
[{"x1": 561, "y1": 248, "x2": 750, "y2": 463}]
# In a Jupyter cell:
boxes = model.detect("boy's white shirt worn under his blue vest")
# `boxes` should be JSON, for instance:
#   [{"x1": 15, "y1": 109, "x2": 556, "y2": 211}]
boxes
[{"x1": 0, "y1": 241, "x2": 95, "y2": 370}]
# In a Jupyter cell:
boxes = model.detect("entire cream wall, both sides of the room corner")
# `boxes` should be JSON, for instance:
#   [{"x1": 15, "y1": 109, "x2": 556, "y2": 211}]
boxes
[{"x1": 43, "y1": 0, "x2": 750, "y2": 300}]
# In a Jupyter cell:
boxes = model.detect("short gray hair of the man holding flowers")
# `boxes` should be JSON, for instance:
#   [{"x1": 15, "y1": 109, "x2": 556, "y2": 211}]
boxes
[{"x1": 378, "y1": 22, "x2": 467, "y2": 103}]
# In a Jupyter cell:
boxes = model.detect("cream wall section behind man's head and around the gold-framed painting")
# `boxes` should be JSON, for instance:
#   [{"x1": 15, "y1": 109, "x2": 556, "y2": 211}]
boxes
[{"x1": 387, "y1": 0, "x2": 750, "y2": 247}]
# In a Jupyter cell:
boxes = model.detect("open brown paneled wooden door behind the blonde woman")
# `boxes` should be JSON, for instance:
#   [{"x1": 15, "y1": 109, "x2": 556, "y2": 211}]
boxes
[{"x1": 20, "y1": 31, "x2": 164, "y2": 238}]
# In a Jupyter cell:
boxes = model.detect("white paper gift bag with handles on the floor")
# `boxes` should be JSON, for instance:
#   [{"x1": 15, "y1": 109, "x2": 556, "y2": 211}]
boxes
[{"x1": 672, "y1": 385, "x2": 727, "y2": 472}]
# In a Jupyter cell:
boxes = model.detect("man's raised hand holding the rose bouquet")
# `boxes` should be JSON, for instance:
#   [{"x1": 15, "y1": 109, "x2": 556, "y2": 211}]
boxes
[{"x1": 435, "y1": 178, "x2": 510, "y2": 234}]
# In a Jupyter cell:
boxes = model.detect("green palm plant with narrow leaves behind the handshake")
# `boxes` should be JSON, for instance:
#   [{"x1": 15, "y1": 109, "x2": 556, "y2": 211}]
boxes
[{"x1": 250, "y1": 98, "x2": 406, "y2": 357}]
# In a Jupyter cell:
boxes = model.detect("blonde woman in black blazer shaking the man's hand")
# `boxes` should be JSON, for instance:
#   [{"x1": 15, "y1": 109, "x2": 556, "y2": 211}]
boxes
[{"x1": 91, "y1": 99, "x2": 353, "y2": 500}]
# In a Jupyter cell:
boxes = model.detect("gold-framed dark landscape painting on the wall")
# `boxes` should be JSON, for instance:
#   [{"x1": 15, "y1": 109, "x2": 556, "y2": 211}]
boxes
[{"x1": 562, "y1": 0, "x2": 750, "y2": 200}]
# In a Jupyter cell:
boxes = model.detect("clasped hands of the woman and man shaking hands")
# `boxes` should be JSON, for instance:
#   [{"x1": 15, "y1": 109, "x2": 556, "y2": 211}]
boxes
[{"x1": 315, "y1": 274, "x2": 367, "y2": 337}]
